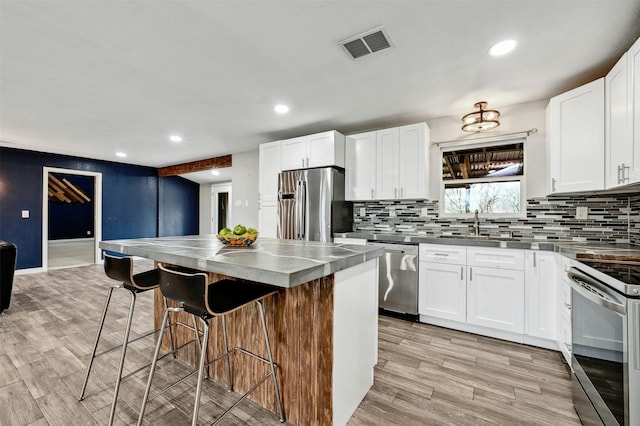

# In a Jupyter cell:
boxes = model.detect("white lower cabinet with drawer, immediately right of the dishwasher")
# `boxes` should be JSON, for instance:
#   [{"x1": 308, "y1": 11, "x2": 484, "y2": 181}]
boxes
[{"x1": 418, "y1": 244, "x2": 467, "y2": 323}]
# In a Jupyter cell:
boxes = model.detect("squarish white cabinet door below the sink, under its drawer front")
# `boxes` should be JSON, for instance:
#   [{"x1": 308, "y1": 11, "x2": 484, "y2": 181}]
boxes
[{"x1": 467, "y1": 266, "x2": 524, "y2": 334}]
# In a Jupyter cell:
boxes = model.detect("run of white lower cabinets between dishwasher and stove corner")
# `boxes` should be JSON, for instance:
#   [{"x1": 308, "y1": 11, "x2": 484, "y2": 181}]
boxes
[{"x1": 418, "y1": 244, "x2": 571, "y2": 349}]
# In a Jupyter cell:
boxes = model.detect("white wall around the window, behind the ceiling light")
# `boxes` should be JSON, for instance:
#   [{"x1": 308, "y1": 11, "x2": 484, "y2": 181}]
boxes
[{"x1": 427, "y1": 100, "x2": 549, "y2": 200}]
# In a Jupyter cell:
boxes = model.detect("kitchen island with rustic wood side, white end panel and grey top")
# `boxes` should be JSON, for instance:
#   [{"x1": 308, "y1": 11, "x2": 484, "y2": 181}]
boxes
[{"x1": 100, "y1": 235, "x2": 382, "y2": 425}]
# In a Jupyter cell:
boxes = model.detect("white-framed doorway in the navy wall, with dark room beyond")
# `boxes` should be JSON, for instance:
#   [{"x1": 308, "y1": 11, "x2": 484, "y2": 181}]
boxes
[{"x1": 42, "y1": 167, "x2": 102, "y2": 270}]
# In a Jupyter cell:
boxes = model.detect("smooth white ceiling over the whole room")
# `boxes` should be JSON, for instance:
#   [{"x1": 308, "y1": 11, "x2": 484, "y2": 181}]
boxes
[{"x1": 0, "y1": 0, "x2": 640, "y2": 183}]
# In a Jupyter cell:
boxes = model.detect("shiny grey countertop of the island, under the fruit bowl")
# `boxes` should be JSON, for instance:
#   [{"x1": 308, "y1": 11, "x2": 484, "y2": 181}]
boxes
[{"x1": 100, "y1": 235, "x2": 383, "y2": 288}]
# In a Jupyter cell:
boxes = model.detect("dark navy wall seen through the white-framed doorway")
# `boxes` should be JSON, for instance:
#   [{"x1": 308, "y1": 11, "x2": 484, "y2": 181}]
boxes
[{"x1": 49, "y1": 173, "x2": 95, "y2": 240}]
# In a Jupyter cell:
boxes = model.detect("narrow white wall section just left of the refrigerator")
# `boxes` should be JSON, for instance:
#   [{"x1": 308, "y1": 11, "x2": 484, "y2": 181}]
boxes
[{"x1": 231, "y1": 149, "x2": 258, "y2": 228}]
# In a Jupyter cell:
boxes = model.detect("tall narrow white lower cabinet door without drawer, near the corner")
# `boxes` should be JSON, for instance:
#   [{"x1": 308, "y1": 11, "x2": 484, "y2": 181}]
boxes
[{"x1": 524, "y1": 250, "x2": 557, "y2": 347}]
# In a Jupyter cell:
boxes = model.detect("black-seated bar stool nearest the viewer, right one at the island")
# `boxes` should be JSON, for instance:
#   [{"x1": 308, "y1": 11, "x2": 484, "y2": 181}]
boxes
[{"x1": 138, "y1": 265, "x2": 285, "y2": 426}]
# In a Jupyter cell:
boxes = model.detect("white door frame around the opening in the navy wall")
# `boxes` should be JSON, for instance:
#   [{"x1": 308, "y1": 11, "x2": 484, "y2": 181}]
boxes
[{"x1": 42, "y1": 166, "x2": 102, "y2": 271}]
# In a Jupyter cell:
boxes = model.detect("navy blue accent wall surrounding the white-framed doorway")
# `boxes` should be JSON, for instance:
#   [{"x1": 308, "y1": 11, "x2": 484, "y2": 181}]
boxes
[{"x1": 0, "y1": 147, "x2": 199, "y2": 269}]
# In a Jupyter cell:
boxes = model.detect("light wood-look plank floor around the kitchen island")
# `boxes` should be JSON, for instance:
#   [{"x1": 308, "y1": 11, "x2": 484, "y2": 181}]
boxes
[{"x1": 0, "y1": 261, "x2": 580, "y2": 426}]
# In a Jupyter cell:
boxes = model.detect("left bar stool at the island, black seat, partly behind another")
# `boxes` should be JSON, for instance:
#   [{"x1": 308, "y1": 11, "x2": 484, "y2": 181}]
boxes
[{"x1": 79, "y1": 253, "x2": 182, "y2": 425}]
